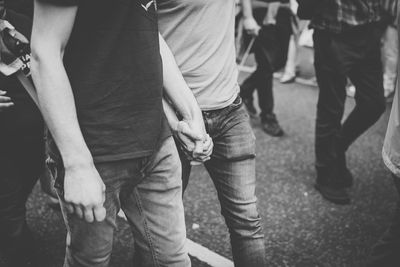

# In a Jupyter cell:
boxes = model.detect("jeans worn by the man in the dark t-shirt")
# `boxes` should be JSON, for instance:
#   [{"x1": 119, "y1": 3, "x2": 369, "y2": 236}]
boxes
[{"x1": 48, "y1": 137, "x2": 190, "y2": 267}]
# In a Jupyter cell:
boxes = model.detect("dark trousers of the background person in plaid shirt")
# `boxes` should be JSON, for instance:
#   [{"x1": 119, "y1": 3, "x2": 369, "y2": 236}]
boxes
[{"x1": 314, "y1": 24, "x2": 386, "y2": 176}]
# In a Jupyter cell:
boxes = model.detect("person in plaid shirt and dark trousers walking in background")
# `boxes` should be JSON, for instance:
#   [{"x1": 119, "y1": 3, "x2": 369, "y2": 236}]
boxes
[{"x1": 311, "y1": 0, "x2": 386, "y2": 204}]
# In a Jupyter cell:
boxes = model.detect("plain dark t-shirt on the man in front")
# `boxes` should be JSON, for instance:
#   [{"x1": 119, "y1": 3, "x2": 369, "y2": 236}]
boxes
[{"x1": 41, "y1": 0, "x2": 170, "y2": 162}]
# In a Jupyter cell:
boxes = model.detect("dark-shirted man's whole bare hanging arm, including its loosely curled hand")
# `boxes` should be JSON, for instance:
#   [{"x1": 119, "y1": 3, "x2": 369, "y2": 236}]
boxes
[{"x1": 31, "y1": 0, "x2": 105, "y2": 222}]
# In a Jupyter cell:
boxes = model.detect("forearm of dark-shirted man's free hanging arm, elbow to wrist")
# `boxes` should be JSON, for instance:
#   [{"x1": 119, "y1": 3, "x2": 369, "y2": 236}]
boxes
[{"x1": 31, "y1": 51, "x2": 93, "y2": 167}]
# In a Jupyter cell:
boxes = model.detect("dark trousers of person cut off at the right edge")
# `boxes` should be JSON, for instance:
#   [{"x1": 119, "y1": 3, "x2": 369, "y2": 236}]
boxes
[{"x1": 367, "y1": 176, "x2": 400, "y2": 267}]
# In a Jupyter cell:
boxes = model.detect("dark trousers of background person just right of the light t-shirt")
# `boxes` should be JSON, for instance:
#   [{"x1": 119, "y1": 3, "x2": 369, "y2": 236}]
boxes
[{"x1": 241, "y1": 8, "x2": 292, "y2": 118}]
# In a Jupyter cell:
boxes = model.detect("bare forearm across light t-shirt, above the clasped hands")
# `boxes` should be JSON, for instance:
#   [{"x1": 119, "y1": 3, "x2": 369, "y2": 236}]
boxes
[{"x1": 160, "y1": 35, "x2": 202, "y2": 119}]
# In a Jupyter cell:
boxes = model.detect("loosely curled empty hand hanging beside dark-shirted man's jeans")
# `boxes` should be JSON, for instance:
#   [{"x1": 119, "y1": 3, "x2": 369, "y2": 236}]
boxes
[{"x1": 64, "y1": 164, "x2": 106, "y2": 223}]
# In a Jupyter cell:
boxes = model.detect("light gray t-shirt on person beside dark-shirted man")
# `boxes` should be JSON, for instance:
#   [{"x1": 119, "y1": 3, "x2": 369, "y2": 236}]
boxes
[{"x1": 157, "y1": 0, "x2": 239, "y2": 110}]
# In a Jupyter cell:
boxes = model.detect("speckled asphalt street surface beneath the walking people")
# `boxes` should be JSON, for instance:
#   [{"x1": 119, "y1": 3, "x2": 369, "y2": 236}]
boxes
[{"x1": 0, "y1": 76, "x2": 397, "y2": 267}]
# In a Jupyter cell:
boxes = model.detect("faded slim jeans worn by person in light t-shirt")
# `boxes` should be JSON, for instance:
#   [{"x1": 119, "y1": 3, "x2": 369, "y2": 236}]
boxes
[{"x1": 180, "y1": 97, "x2": 267, "y2": 267}]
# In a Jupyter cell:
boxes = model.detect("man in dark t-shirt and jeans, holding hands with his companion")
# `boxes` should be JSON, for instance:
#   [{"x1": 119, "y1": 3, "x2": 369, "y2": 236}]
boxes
[{"x1": 31, "y1": 0, "x2": 207, "y2": 266}]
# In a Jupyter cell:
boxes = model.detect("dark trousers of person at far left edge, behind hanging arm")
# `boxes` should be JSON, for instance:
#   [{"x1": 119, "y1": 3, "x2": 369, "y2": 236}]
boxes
[{"x1": 0, "y1": 93, "x2": 44, "y2": 267}]
